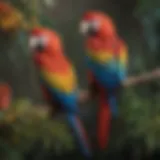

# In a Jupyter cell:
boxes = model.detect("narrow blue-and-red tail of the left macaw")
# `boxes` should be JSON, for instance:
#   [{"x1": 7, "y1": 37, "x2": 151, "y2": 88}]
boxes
[{"x1": 67, "y1": 114, "x2": 91, "y2": 157}]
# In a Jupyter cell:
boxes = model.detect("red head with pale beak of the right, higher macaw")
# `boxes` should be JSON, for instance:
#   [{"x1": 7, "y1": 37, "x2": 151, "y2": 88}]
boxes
[{"x1": 80, "y1": 11, "x2": 116, "y2": 37}]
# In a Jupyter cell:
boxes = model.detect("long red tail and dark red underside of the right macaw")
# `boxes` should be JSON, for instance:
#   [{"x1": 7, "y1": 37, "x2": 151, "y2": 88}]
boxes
[{"x1": 87, "y1": 71, "x2": 111, "y2": 149}]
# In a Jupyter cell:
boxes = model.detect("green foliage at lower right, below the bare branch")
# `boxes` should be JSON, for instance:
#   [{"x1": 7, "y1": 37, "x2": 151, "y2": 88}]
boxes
[{"x1": 121, "y1": 86, "x2": 160, "y2": 149}]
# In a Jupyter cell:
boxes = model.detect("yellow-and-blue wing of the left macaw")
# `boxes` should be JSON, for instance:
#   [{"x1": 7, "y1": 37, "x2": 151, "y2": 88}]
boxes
[{"x1": 41, "y1": 71, "x2": 78, "y2": 111}]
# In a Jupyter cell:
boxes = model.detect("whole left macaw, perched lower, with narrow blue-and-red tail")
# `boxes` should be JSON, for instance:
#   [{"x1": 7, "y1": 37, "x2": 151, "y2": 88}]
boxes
[{"x1": 29, "y1": 27, "x2": 91, "y2": 157}]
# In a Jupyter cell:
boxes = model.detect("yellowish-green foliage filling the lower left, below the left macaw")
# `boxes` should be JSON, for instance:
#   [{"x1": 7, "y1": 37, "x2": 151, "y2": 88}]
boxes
[{"x1": 0, "y1": 99, "x2": 73, "y2": 159}]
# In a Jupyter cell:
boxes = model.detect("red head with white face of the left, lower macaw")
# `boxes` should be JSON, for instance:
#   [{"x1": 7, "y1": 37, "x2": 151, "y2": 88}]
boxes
[{"x1": 29, "y1": 28, "x2": 62, "y2": 65}]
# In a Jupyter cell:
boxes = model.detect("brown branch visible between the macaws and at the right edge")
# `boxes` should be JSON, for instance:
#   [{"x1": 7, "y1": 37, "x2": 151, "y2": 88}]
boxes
[{"x1": 79, "y1": 68, "x2": 160, "y2": 103}]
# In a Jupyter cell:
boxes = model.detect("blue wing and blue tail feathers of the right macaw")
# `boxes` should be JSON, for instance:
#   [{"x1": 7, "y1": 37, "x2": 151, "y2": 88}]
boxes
[{"x1": 87, "y1": 57, "x2": 122, "y2": 117}]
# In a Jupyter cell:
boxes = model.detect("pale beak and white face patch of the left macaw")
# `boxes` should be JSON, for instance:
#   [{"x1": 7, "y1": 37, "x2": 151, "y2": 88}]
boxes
[{"x1": 29, "y1": 36, "x2": 47, "y2": 51}]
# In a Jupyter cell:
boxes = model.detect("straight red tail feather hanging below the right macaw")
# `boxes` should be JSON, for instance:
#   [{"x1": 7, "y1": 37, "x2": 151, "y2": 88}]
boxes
[{"x1": 97, "y1": 92, "x2": 111, "y2": 150}]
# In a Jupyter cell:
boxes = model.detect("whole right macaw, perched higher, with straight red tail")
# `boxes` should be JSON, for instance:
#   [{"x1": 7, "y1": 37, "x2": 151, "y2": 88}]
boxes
[{"x1": 80, "y1": 11, "x2": 127, "y2": 149}]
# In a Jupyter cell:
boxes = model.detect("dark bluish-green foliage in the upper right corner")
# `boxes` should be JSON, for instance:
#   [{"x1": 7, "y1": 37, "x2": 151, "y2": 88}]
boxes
[{"x1": 135, "y1": 0, "x2": 160, "y2": 57}]
